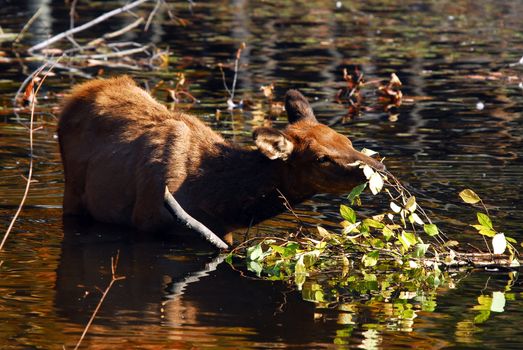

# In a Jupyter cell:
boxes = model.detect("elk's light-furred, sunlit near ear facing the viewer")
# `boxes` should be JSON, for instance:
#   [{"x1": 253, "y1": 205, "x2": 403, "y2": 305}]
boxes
[{"x1": 253, "y1": 128, "x2": 294, "y2": 160}]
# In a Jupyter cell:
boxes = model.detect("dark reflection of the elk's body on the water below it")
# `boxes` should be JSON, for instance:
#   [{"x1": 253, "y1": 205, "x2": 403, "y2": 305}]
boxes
[{"x1": 55, "y1": 220, "x2": 342, "y2": 344}]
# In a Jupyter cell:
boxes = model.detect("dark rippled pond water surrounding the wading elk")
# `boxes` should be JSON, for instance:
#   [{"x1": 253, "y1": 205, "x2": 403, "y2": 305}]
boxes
[{"x1": 0, "y1": 0, "x2": 523, "y2": 349}]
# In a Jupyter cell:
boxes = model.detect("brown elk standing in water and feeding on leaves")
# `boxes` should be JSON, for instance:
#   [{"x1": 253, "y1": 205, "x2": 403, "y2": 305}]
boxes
[{"x1": 58, "y1": 76, "x2": 384, "y2": 248}]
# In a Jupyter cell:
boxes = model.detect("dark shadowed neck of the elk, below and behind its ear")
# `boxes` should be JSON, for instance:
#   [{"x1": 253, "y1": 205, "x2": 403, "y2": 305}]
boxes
[{"x1": 180, "y1": 144, "x2": 314, "y2": 230}]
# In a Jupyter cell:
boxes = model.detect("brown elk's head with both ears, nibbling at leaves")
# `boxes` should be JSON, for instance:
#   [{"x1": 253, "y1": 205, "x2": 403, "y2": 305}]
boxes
[{"x1": 254, "y1": 90, "x2": 385, "y2": 195}]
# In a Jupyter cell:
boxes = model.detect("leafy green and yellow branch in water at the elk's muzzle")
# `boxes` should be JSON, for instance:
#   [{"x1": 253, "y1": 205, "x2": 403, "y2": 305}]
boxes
[{"x1": 227, "y1": 156, "x2": 519, "y2": 308}]
